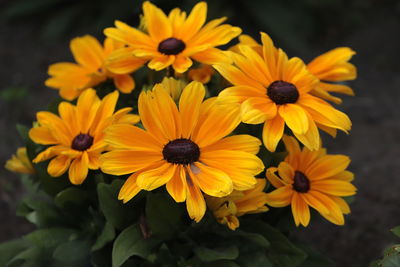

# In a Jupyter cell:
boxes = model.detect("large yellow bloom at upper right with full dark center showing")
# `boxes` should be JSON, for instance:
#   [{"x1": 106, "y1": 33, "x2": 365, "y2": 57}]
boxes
[{"x1": 214, "y1": 33, "x2": 351, "y2": 151}]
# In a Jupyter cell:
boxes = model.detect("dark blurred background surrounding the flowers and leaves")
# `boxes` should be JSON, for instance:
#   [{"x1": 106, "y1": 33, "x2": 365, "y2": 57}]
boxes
[{"x1": 0, "y1": 0, "x2": 400, "y2": 267}]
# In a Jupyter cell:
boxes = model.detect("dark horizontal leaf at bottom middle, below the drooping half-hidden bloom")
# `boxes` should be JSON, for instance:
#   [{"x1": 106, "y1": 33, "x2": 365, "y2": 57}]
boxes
[{"x1": 193, "y1": 246, "x2": 239, "y2": 262}]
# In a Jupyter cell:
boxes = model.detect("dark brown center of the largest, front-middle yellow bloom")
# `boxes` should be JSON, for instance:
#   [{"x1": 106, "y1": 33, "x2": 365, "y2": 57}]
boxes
[{"x1": 163, "y1": 138, "x2": 200, "y2": 165}]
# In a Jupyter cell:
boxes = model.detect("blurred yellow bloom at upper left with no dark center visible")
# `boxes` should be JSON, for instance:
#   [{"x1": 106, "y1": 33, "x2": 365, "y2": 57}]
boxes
[{"x1": 45, "y1": 35, "x2": 145, "y2": 100}]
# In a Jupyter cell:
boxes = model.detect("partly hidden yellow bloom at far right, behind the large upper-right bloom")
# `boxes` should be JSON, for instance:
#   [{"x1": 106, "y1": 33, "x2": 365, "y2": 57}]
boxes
[{"x1": 307, "y1": 47, "x2": 357, "y2": 104}]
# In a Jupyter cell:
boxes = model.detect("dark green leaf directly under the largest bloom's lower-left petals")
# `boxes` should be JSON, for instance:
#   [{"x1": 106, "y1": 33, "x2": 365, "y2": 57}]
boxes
[{"x1": 97, "y1": 179, "x2": 135, "y2": 229}]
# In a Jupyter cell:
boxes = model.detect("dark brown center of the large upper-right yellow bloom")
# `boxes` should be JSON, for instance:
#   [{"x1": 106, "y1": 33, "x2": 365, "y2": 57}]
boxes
[{"x1": 267, "y1": 81, "x2": 299, "y2": 105}]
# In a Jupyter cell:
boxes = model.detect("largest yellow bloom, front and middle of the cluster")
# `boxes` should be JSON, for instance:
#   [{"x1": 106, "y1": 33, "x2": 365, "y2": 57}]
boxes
[{"x1": 101, "y1": 82, "x2": 264, "y2": 222}]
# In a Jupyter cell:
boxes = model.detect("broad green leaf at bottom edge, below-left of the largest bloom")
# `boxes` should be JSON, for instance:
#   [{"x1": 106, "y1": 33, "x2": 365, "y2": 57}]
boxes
[{"x1": 112, "y1": 224, "x2": 160, "y2": 267}]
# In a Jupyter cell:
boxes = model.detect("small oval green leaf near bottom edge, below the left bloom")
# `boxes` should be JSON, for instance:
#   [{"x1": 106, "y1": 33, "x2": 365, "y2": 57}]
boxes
[{"x1": 53, "y1": 240, "x2": 90, "y2": 262}]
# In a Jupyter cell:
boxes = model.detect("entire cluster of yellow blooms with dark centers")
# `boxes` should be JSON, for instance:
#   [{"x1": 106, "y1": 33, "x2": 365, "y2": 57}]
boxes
[{"x1": 7, "y1": 2, "x2": 356, "y2": 230}]
